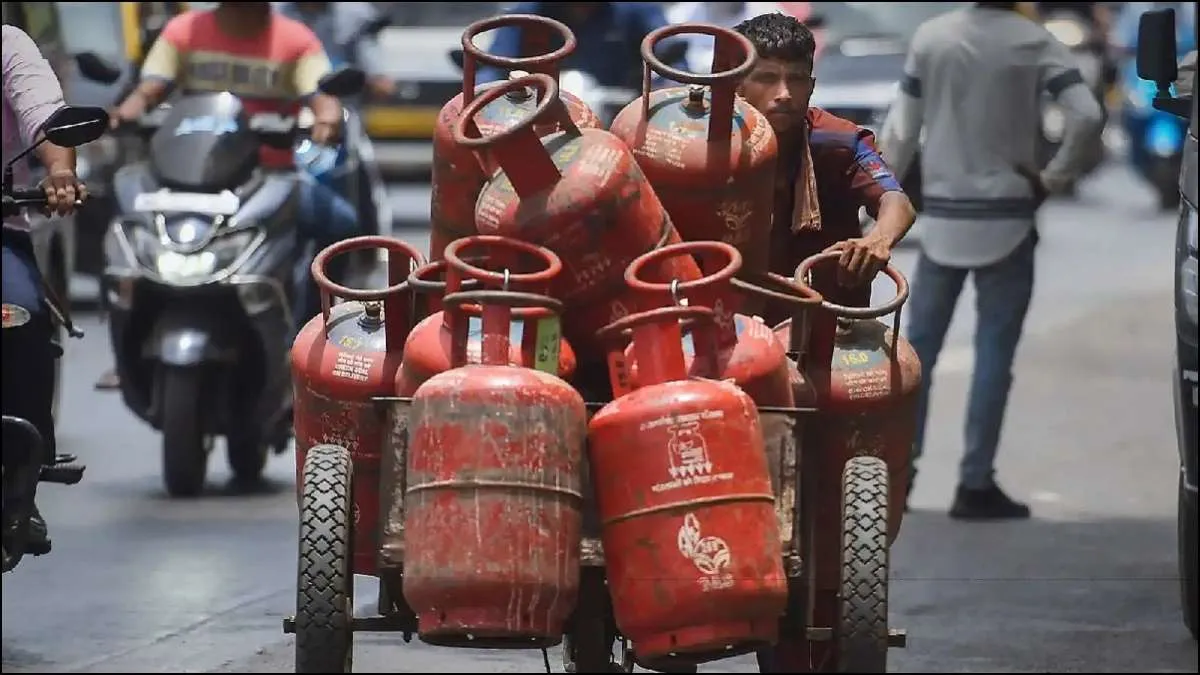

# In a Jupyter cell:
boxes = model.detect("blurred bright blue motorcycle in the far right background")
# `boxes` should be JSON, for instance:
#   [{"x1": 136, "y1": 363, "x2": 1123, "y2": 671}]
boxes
[{"x1": 1121, "y1": 59, "x2": 1188, "y2": 210}]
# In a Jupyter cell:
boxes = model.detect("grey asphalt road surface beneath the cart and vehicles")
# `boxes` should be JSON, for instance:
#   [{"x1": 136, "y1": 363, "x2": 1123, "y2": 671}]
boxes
[{"x1": 2, "y1": 159, "x2": 1196, "y2": 673}]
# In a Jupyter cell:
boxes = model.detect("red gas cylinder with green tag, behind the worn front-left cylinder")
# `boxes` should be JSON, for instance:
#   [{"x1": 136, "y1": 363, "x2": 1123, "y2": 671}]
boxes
[{"x1": 396, "y1": 235, "x2": 575, "y2": 396}]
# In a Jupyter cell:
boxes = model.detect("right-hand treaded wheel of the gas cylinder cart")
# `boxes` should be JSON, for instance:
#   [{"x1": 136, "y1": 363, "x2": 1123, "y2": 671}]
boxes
[{"x1": 838, "y1": 456, "x2": 889, "y2": 673}]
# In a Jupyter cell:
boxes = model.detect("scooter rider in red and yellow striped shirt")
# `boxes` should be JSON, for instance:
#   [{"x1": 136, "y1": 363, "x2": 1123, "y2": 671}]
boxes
[{"x1": 104, "y1": 2, "x2": 359, "y2": 383}]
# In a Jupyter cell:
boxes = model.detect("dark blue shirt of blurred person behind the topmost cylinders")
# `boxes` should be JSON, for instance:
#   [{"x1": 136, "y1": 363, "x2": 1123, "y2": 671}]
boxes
[{"x1": 475, "y1": 2, "x2": 686, "y2": 86}]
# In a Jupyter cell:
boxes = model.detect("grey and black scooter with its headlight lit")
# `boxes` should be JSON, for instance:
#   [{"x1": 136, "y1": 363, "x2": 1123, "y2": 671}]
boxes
[{"x1": 71, "y1": 58, "x2": 365, "y2": 496}]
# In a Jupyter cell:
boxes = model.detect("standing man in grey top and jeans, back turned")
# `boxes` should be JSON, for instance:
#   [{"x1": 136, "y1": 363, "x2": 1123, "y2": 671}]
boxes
[{"x1": 880, "y1": 2, "x2": 1103, "y2": 520}]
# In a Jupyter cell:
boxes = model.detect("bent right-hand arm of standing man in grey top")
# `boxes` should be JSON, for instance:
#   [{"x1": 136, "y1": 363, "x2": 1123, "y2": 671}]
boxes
[{"x1": 1022, "y1": 32, "x2": 1104, "y2": 192}]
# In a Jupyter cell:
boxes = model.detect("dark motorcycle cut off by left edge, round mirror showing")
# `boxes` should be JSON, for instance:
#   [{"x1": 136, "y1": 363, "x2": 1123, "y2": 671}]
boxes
[{"x1": 0, "y1": 106, "x2": 108, "y2": 573}]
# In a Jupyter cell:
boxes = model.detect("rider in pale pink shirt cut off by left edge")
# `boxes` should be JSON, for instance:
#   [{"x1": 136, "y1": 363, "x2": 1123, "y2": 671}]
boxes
[{"x1": 0, "y1": 24, "x2": 88, "y2": 555}]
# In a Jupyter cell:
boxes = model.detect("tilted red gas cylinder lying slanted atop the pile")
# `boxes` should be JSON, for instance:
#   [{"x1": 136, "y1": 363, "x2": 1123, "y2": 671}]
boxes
[{"x1": 455, "y1": 74, "x2": 700, "y2": 362}]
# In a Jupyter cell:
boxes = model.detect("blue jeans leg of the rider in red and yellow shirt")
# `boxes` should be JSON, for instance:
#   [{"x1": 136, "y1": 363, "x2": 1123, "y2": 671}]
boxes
[{"x1": 293, "y1": 175, "x2": 360, "y2": 331}]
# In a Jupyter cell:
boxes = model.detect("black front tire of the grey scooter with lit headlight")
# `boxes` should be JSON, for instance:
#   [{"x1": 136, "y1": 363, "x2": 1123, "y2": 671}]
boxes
[{"x1": 160, "y1": 368, "x2": 209, "y2": 497}]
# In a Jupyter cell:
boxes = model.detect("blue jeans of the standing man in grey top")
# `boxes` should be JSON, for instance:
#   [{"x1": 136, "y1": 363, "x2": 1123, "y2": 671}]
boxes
[{"x1": 906, "y1": 231, "x2": 1038, "y2": 489}]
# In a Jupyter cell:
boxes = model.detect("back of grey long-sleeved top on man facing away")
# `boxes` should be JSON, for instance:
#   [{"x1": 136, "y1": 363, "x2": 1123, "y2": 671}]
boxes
[{"x1": 902, "y1": 6, "x2": 1098, "y2": 265}]
